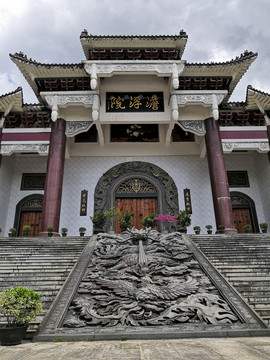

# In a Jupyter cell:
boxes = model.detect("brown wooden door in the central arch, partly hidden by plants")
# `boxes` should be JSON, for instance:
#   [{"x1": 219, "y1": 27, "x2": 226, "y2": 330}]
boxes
[{"x1": 115, "y1": 197, "x2": 158, "y2": 233}]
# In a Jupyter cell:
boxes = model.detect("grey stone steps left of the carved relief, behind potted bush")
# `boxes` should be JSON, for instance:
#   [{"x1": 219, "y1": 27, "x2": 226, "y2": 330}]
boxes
[{"x1": 0, "y1": 237, "x2": 89, "y2": 337}]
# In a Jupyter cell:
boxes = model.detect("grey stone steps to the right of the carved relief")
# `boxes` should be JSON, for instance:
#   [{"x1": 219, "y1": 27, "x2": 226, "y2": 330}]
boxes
[{"x1": 190, "y1": 234, "x2": 270, "y2": 326}]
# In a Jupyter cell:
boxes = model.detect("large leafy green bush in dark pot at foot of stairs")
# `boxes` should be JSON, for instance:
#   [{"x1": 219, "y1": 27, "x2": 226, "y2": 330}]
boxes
[{"x1": 0, "y1": 287, "x2": 42, "y2": 345}]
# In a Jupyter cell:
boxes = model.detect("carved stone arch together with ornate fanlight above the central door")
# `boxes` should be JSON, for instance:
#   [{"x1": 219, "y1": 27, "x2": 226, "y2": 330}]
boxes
[{"x1": 94, "y1": 161, "x2": 179, "y2": 232}]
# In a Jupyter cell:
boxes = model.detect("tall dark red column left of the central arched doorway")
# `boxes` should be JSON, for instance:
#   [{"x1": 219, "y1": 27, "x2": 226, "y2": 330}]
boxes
[{"x1": 39, "y1": 119, "x2": 66, "y2": 236}]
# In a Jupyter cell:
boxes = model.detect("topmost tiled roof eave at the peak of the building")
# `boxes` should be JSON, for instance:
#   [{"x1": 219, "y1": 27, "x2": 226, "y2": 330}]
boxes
[{"x1": 80, "y1": 36, "x2": 187, "y2": 60}]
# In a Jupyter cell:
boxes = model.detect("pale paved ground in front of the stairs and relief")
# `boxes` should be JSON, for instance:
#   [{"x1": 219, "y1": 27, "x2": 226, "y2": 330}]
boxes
[{"x1": 0, "y1": 337, "x2": 270, "y2": 360}]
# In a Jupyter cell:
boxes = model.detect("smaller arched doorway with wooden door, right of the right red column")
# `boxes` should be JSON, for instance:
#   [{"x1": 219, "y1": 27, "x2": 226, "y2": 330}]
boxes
[{"x1": 231, "y1": 191, "x2": 260, "y2": 234}]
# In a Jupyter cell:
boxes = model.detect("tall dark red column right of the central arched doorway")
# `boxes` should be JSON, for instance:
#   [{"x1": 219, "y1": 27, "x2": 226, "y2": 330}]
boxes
[{"x1": 205, "y1": 118, "x2": 236, "y2": 234}]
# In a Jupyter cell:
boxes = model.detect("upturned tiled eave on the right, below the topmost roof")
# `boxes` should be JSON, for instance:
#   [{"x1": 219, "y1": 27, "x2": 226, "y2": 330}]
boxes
[{"x1": 184, "y1": 53, "x2": 257, "y2": 102}]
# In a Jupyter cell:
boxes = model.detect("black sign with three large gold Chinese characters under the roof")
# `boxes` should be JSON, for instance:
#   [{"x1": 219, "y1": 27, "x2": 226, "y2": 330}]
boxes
[{"x1": 106, "y1": 92, "x2": 164, "y2": 112}]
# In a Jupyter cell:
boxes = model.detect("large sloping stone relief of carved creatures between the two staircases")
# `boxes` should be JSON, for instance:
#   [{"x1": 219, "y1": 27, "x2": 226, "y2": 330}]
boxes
[{"x1": 63, "y1": 228, "x2": 239, "y2": 328}]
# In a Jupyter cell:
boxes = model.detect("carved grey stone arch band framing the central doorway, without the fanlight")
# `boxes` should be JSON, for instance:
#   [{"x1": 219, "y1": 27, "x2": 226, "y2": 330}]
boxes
[{"x1": 94, "y1": 161, "x2": 179, "y2": 215}]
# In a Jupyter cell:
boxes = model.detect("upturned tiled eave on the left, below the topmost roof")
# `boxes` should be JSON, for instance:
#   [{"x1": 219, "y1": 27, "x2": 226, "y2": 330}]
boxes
[{"x1": 10, "y1": 55, "x2": 86, "y2": 102}]
